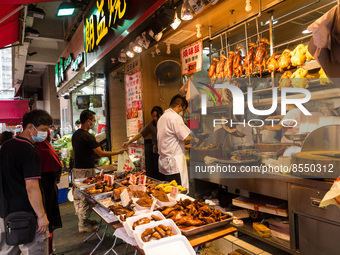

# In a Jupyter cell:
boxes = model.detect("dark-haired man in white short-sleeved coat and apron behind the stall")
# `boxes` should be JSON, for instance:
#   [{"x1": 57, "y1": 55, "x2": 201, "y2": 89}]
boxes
[{"x1": 157, "y1": 94, "x2": 190, "y2": 188}]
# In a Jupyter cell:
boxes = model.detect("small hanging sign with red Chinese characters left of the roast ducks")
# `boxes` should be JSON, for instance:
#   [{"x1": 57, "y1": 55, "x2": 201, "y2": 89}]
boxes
[{"x1": 181, "y1": 40, "x2": 203, "y2": 75}]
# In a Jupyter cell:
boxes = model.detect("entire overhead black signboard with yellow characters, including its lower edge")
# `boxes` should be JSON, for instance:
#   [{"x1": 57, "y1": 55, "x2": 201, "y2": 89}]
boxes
[{"x1": 84, "y1": 0, "x2": 166, "y2": 71}]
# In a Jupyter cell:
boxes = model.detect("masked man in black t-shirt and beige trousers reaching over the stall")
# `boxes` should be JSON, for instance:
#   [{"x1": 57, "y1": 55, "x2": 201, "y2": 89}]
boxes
[{"x1": 72, "y1": 110, "x2": 125, "y2": 233}]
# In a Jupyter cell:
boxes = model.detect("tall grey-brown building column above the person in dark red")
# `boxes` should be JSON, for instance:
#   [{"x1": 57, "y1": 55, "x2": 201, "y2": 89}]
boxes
[{"x1": 41, "y1": 65, "x2": 60, "y2": 126}]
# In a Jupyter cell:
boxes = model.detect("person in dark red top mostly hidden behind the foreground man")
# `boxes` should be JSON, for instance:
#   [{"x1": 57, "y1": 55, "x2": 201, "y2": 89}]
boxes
[{"x1": 35, "y1": 131, "x2": 62, "y2": 254}]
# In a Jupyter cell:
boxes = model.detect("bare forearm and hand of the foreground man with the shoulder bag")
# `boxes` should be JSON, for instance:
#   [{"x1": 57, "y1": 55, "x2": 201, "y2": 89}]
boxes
[{"x1": 25, "y1": 179, "x2": 49, "y2": 234}]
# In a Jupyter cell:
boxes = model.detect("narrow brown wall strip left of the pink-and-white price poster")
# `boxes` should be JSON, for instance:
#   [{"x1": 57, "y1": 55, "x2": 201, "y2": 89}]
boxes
[{"x1": 108, "y1": 70, "x2": 127, "y2": 156}]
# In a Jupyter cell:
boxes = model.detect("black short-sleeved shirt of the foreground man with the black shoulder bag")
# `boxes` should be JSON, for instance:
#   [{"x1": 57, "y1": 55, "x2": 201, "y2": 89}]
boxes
[{"x1": 0, "y1": 137, "x2": 40, "y2": 216}]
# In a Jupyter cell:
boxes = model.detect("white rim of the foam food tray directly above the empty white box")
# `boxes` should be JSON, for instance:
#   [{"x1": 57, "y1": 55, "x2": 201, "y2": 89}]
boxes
[{"x1": 133, "y1": 219, "x2": 181, "y2": 249}]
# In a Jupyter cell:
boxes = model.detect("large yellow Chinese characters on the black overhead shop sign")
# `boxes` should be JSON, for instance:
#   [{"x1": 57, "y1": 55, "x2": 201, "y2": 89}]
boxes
[{"x1": 84, "y1": 0, "x2": 126, "y2": 52}]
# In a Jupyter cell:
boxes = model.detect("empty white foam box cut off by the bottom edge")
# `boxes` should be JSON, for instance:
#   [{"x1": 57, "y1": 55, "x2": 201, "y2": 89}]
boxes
[{"x1": 144, "y1": 235, "x2": 196, "y2": 255}]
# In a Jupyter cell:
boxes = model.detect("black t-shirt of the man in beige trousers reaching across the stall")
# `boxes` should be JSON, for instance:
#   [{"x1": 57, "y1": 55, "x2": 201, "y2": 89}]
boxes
[{"x1": 72, "y1": 129, "x2": 100, "y2": 168}]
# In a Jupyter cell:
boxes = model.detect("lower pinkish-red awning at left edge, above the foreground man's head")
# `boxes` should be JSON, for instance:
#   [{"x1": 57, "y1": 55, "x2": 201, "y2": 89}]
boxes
[{"x1": 0, "y1": 100, "x2": 29, "y2": 124}]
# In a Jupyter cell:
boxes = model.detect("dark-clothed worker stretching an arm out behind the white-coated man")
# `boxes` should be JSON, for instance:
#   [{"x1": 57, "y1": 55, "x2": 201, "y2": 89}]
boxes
[{"x1": 123, "y1": 106, "x2": 163, "y2": 179}]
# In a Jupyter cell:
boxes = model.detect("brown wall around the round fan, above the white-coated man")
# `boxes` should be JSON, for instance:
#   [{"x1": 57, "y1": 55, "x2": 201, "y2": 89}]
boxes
[{"x1": 141, "y1": 53, "x2": 182, "y2": 124}]
